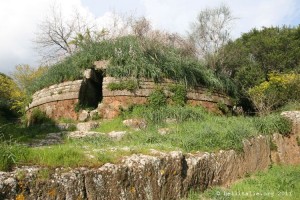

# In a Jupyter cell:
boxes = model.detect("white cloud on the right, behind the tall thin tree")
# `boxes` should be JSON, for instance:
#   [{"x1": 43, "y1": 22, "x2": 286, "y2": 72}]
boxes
[{"x1": 142, "y1": 0, "x2": 300, "y2": 37}]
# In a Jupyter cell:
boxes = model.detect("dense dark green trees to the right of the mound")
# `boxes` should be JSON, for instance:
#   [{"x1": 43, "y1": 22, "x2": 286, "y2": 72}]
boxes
[{"x1": 218, "y1": 26, "x2": 300, "y2": 87}]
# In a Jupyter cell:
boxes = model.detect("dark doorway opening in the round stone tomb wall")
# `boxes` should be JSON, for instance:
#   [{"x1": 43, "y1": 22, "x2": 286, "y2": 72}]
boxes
[{"x1": 79, "y1": 69, "x2": 103, "y2": 108}]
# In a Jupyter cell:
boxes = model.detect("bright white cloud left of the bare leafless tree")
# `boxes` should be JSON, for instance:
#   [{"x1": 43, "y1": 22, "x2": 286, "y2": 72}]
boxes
[{"x1": 0, "y1": 0, "x2": 91, "y2": 73}]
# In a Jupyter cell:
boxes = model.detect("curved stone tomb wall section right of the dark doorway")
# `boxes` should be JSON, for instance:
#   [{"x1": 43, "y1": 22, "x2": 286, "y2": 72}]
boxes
[{"x1": 99, "y1": 77, "x2": 232, "y2": 118}]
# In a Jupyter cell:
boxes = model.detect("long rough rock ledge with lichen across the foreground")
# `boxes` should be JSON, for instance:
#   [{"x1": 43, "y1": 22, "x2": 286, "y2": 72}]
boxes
[{"x1": 0, "y1": 111, "x2": 300, "y2": 200}]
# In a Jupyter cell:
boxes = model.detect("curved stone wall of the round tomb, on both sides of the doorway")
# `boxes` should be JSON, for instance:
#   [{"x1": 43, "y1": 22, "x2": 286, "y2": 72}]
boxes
[{"x1": 27, "y1": 75, "x2": 231, "y2": 120}]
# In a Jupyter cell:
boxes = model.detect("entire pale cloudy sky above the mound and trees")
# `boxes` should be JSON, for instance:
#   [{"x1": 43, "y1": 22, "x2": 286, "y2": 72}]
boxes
[{"x1": 0, "y1": 0, "x2": 300, "y2": 74}]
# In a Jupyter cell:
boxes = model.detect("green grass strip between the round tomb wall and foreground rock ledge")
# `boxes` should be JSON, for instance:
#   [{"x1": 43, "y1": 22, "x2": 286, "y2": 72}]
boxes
[{"x1": 1, "y1": 106, "x2": 291, "y2": 169}]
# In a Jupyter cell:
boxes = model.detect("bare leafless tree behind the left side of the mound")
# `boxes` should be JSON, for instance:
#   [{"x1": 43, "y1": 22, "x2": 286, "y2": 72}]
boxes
[{"x1": 34, "y1": 4, "x2": 95, "y2": 62}]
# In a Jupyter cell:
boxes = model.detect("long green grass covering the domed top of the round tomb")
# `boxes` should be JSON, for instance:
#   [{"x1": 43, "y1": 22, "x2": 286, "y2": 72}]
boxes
[{"x1": 30, "y1": 36, "x2": 234, "y2": 94}]
